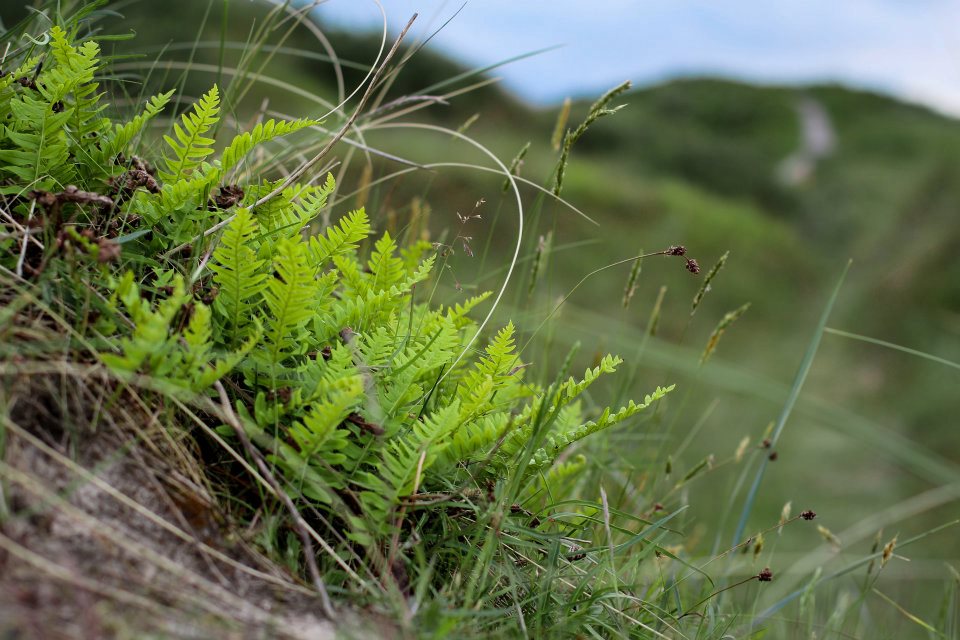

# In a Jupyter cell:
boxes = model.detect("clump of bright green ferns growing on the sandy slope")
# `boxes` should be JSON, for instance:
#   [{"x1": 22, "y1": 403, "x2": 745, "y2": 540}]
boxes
[{"x1": 0, "y1": 17, "x2": 681, "y2": 636}]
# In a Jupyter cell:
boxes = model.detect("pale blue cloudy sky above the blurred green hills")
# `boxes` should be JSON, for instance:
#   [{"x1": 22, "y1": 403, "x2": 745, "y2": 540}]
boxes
[{"x1": 317, "y1": 0, "x2": 960, "y2": 116}]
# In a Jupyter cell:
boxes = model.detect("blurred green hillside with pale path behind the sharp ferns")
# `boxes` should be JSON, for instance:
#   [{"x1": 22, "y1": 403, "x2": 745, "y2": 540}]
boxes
[{"x1": 3, "y1": 0, "x2": 960, "y2": 624}]
